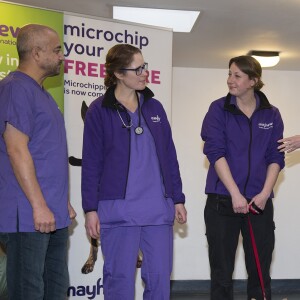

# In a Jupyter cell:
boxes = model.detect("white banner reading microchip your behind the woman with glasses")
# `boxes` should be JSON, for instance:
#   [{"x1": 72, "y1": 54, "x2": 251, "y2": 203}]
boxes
[{"x1": 64, "y1": 14, "x2": 172, "y2": 299}]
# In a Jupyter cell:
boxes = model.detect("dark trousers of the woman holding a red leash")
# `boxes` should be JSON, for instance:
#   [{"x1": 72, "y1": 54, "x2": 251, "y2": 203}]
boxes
[{"x1": 204, "y1": 195, "x2": 275, "y2": 300}]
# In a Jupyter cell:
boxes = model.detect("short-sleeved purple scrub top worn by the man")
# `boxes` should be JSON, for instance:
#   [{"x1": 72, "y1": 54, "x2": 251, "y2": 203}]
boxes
[{"x1": 0, "y1": 71, "x2": 70, "y2": 232}]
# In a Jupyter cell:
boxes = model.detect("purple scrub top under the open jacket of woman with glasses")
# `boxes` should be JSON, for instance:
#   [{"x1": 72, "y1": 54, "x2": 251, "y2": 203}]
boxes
[{"x1": 98, "y1": 103, "x2": 175, "y2": 228}]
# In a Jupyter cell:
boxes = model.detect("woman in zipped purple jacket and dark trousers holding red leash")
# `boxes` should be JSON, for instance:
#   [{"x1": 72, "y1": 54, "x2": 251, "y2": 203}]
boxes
[{"x1": 201, "y1": 56, "x2": 284, "y2": 300}]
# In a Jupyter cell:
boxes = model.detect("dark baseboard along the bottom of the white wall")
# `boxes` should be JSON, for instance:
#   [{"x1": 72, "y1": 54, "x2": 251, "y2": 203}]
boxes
[{"x1": 171, "y1": 279, "x2": 300, "y2": 294}]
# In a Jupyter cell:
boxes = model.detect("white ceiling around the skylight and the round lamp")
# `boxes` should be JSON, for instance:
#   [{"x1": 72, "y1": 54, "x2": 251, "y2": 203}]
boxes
[{"x1": 10, "y1": 0, "x2": 300, "y2": 71}]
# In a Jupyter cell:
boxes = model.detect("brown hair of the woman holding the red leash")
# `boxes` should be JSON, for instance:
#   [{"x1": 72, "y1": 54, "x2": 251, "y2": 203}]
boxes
[{"x1": 229, "y1": 55, "x2": 264, "y2": 90}]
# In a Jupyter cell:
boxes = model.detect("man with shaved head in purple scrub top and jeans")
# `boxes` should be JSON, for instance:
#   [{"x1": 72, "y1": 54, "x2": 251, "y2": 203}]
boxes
[{"x1": 0, "y1": 24, "x2": 76, "y2": 300}]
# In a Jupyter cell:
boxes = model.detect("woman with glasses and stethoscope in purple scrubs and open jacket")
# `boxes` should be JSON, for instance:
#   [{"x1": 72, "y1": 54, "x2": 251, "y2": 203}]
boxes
[{"x1": 82, "y1": 44, "x2": 186, "y2": 300}]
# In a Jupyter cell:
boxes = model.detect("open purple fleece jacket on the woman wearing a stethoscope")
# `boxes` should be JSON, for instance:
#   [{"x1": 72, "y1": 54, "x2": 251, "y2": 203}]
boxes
[{"x1": 81, "y1": 87, "x2": 185, "y2": 212}]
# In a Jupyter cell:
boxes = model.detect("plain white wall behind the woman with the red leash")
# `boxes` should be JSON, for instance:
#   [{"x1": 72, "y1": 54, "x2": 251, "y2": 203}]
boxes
[{"x1": 172, "y1": 68, "x2": 300, "y2": 280}]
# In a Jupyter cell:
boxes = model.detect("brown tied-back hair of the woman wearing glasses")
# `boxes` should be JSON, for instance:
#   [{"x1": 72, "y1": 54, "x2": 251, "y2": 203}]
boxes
[{"x1": 104, "y1": 44, "x2": 141, "y2": 87}]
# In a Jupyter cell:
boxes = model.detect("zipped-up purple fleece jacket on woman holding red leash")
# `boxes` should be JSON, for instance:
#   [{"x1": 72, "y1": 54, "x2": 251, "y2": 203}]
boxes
[{"x1": 201, "y1": 91, "x2": 284, "y2": 199}]
